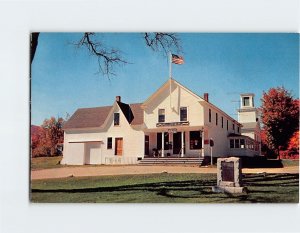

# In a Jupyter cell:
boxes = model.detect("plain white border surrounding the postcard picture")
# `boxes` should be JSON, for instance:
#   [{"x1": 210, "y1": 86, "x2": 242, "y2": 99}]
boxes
[{"x1": 0, "y1": 0, "x2": 300, "y2": 233}]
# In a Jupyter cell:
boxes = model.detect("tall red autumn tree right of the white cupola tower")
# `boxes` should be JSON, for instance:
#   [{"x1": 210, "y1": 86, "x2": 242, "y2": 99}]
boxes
[{"x1": 261, "y1": 87, "x2": 299, "y2": 158}]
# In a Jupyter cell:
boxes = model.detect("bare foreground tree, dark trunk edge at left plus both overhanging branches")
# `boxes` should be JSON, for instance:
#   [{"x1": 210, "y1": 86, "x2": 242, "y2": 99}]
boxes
[{"x1": 30, "y1": 32, "x2": 182, "y2": 78}]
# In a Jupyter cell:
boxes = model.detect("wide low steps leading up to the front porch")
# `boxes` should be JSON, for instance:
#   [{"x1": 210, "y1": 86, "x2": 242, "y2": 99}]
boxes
[{"x1": 139, "y1": 157, "x2": 203, "y2": 165}]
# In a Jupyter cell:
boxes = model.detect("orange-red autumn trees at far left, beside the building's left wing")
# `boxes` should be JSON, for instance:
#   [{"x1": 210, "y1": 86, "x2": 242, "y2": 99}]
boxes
[{"x1": 31, "y1": 117, "x2": 64, "y2": 157}]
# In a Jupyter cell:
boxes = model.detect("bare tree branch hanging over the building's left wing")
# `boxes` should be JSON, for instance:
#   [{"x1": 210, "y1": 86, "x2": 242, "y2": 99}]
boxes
[{"x1": 75, "y1": 32, "x2": 128, "y2": 78}]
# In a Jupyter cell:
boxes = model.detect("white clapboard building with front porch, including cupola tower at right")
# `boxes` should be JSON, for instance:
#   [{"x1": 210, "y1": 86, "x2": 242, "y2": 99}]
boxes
[{"x1": 61, "y1": 79, "x2": 260, "y2": 164}]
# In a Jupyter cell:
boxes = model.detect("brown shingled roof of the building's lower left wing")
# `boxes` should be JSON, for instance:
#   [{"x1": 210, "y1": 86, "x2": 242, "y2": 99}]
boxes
[{"x1": 63, "y1": 102, "x2": 144, "y2": 129}]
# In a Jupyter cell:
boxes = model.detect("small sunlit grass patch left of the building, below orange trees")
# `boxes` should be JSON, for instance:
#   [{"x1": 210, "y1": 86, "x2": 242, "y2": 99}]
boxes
[{"x1": 31, "y1": 156, "x2": 63, "y2": 170}]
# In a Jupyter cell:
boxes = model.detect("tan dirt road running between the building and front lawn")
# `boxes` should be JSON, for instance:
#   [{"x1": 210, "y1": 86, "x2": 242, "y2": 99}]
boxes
[{"x1": 31, "y1": 166, "x2": 299, "y2": 180}]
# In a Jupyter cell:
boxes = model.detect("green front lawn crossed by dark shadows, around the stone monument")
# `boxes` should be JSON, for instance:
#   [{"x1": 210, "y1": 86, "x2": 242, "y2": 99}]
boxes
[{"x1": 31, "y1": 174, "x2": 299, "y2": 203}]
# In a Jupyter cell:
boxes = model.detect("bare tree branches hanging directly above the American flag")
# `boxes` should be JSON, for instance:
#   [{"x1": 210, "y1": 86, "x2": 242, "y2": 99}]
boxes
[{"x1": 144, "y1": 32, "x2": 182, "y2": 55}]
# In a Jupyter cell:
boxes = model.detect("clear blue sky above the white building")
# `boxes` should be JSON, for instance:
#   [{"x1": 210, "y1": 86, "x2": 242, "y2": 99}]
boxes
[{"x1": 31, "y1": 33, "x2": 299, "y2": 125}]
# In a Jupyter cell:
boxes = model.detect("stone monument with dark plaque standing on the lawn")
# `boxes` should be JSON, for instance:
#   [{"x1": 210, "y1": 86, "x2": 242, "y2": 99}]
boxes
[{"x1": 212, "y1": 157, "x2": 247, "y2": 193}]
